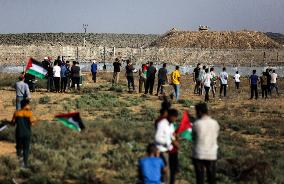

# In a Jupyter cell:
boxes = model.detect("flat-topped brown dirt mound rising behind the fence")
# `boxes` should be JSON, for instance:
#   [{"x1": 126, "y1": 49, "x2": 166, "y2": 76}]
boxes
[{"x1": 150, "y1": 29, "x2": 281, "y2": 49}]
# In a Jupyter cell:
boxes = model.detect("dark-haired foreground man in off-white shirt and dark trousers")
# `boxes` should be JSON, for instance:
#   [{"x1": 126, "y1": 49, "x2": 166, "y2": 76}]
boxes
[{"x1": 192, "y1": 103, "x2": 220, "y2": 184}]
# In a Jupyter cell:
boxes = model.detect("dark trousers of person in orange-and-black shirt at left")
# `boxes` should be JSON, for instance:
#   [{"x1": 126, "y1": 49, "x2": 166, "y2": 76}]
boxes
[{"x1": 16, "y1": 135, "x2": 31, "y2": 167}]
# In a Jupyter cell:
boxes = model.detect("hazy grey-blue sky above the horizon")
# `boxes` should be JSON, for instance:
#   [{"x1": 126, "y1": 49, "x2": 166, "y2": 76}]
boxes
[{"x1": 0, "y1": 0, "x2": 284, "y2": 34}]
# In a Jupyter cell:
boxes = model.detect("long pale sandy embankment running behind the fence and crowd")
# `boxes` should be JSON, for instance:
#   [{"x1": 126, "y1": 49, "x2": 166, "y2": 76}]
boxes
[{"x1": 0, "y1": 44, "x2": 284, "y2": 65}]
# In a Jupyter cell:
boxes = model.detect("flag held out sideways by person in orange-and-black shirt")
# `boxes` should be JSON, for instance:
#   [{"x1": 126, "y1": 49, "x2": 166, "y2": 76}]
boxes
[{"x1": 55, "y1": 112, "x2": 85, "y2": 132}]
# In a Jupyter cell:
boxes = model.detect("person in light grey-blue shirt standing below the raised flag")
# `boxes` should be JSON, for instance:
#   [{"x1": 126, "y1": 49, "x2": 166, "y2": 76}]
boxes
[{"x1": 15, "y1": 75, "x2": 31, "y2": 110}]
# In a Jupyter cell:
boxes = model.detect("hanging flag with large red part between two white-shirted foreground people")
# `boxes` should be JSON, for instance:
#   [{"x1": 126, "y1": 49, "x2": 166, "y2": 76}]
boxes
[{"x1": 176, "y1": 111, "x2": 192, "y2": 141}]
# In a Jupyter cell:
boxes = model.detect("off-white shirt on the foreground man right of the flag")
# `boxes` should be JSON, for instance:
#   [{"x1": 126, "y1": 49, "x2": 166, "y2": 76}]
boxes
[{"x1": 192, "y1": 116, "x2": 220, "y2": 160}]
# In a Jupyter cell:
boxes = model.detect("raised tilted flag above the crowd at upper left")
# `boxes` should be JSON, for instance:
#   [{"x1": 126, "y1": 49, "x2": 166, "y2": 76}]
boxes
[{"x1": 26, "y1": 58, "x2": 47, "y2": 79}]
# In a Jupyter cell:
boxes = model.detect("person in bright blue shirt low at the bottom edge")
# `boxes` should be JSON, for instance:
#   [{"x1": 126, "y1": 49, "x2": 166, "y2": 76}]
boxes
[{"x1": 138, "y1": 143, "x2": 167, "y2": 184}]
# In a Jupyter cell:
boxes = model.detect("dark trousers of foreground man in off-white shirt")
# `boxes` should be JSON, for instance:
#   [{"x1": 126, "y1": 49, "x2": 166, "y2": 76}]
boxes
[{"x1": 192, "y1": 158, "x2": 216, "y2": 184}]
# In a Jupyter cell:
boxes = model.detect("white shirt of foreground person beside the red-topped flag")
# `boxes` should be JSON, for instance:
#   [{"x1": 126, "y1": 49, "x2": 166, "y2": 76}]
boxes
[{"x1": 155, "y1": 119, "x2": 173, "y2": 152}]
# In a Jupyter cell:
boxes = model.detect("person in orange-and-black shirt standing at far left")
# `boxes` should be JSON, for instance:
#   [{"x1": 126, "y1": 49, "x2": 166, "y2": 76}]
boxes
[{"x1": 11, "y1": 99, "x2": 35, "y2": 168}]
